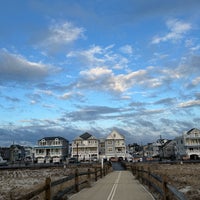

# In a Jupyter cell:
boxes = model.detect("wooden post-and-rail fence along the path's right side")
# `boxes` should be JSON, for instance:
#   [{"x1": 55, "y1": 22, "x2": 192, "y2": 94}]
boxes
[{"x1": 129, "y1": 165, "x2": 187, "y2": 200}]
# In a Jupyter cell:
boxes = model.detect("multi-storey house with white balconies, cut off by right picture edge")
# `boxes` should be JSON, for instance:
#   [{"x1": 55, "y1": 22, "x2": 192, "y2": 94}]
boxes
[{"x1": 175, "y1": 128, "x2": 200, "y2": 159}]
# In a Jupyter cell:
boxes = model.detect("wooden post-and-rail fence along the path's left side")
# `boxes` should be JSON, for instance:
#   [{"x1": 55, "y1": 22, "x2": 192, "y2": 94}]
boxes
[{"x1": 14, "y1": 165, "x2": 110, "y2": 200}]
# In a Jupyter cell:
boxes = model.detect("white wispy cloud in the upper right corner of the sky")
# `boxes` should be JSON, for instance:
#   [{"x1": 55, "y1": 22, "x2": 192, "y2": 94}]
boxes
[{"x1": 152, "y1": 19, "x2": 192, "y2": 44}]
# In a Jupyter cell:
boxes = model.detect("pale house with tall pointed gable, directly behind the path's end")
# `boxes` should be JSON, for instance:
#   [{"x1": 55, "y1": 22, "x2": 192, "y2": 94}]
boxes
[{"x1": 105, "y1": 130, "x2": 126, "y2": 160}]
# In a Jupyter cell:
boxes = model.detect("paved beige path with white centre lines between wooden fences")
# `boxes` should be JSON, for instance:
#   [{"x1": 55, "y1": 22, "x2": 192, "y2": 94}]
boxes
[{"x1": 69, "y1": 171, "x2": 154, "y2": 200}]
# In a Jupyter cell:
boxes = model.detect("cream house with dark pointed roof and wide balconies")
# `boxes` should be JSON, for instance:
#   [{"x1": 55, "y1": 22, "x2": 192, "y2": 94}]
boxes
[{"x1": 71, "y1": 132, "x2": 99, "y2": 161}]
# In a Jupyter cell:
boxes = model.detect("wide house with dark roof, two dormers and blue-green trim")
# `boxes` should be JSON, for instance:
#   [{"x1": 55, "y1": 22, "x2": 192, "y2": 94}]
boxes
[{"x1": 34, "y1": 136, "x2": 69, "y2": 163}]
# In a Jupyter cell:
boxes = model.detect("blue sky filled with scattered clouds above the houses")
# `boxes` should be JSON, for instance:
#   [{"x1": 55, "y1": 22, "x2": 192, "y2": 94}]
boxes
[{"x1": 0, "y1": 0, "x2": 200, "y2": 146}]
